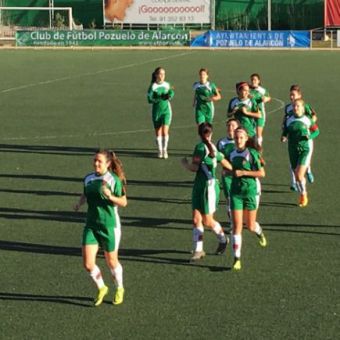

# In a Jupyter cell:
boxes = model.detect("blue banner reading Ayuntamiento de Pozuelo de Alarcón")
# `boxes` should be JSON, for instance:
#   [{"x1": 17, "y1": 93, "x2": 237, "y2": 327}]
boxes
[{"x1": 191, "y1": 31, "x2": 310, "y2": 48}]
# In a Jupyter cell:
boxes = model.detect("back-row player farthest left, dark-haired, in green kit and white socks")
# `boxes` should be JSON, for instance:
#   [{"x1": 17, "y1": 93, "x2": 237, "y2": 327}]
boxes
[{"x1": 147, "y1": 67, "x2": 175, "y2": 159}]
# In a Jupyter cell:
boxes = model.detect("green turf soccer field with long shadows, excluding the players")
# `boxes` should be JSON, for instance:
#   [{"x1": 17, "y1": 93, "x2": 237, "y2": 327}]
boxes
[{"x1": 0, "y1": 49, "x2": 340, "y2": 339}]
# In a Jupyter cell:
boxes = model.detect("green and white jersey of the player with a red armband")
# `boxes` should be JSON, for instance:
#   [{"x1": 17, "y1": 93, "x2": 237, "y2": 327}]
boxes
[{"x1": 282, "y1": 114, "x2": 319, "y2": 148}]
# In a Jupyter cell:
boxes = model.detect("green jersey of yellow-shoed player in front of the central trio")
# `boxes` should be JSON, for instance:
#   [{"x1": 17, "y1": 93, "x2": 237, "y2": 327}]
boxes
[{"x1": 229, "y1": 148, "x2": 262, "y2": 197}]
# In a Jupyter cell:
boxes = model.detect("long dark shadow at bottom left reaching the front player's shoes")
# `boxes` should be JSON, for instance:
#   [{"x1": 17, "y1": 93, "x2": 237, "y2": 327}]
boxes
[{"x1": 0, "y1": 292, "x2": 93, "y2": 307}]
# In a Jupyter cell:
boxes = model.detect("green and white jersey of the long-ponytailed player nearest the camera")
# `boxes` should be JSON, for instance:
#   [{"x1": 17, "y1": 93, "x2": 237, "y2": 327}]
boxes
[{"x1": 84, "y1": 171, "x2": 124, "y2": 229}]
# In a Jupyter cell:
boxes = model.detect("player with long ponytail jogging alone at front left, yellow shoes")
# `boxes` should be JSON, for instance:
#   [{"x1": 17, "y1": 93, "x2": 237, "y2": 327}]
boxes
[{"x1": 74, "y1": 150, "x2": 127, "y2": 306}]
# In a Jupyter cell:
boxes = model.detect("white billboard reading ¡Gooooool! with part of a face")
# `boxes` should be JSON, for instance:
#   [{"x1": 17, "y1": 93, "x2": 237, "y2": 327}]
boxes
[{"x1": 104, "y1": 0, "x2": 211, "y2": 24}]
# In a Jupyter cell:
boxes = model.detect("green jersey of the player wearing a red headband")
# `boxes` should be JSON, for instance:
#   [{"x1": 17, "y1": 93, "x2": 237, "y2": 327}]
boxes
[{"x1": 228, "y1": 97, "x2": 258, "y2": 137}]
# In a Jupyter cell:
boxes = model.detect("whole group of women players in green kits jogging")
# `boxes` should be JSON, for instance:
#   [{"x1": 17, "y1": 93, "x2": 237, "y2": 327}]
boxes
[{"x1": 74, "y1": 67, "x2": 319, "y2": 306}]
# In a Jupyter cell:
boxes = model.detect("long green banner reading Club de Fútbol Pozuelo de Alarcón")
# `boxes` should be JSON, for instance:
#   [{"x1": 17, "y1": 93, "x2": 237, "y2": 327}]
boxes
[{"x1": 16, "y1": 30, "x2": 190, "y2": 46}]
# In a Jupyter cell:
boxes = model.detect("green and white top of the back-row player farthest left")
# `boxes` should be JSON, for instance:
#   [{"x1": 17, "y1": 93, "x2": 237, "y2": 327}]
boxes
[{"x1": 147, "y1": 81, "x2": 175, "y2": 114}]
